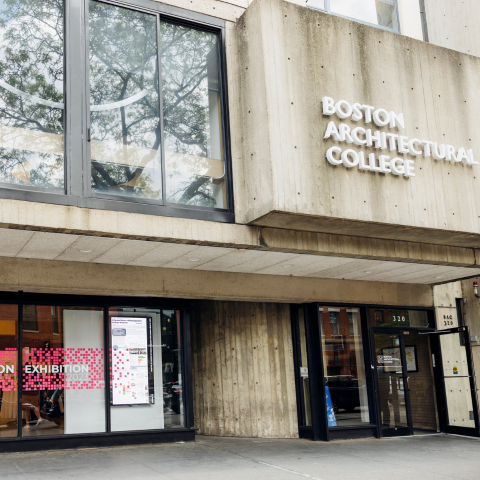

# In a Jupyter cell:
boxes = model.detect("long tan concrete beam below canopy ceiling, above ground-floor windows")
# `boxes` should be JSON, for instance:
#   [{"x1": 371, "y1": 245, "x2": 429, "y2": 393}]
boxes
[{"x1": 0, "y1": 258, "x2": 433, "y2": 307}]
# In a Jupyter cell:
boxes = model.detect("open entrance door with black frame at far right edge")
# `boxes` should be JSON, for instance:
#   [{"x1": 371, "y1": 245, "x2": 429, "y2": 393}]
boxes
[{"x1": 432, "y1": 327, "x2": 480, "y2": 437}]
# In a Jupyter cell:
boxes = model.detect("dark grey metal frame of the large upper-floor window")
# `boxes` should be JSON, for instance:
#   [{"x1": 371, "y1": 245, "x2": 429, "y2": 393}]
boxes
[{"x1": 0, "y1": 0, "x2": 235, "y2": 223}]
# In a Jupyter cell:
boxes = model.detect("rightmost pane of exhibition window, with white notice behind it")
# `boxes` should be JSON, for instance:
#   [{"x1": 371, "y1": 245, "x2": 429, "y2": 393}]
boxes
[{"x1": 109, "y1": 308, "x2": 184, "y2": 431}]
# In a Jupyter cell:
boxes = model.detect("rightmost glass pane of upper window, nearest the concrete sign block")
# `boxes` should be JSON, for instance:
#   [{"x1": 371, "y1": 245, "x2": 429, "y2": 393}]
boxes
[{"x1": 161, "y1": 22, "x2": 227, "y2": 208}]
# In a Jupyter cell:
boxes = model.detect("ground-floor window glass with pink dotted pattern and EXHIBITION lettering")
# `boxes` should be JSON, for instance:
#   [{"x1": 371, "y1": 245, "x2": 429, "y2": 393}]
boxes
[{"x1": 0, "y1": 304, "x2": 186, "y2": 439}]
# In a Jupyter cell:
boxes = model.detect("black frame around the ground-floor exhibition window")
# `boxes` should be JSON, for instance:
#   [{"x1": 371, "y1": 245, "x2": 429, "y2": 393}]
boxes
[{"x1": 0, "y1": 291, "x2": 195, "y2": 452}]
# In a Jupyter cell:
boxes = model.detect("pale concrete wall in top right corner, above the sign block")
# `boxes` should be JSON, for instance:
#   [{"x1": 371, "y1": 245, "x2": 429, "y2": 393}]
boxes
[{"x1": 425, "y1": 0, "x2": 480, "y2": 57}]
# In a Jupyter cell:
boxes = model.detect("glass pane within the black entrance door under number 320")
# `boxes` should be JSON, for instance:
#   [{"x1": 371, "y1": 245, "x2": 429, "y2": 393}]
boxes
[{"x1": 375, "y1": 335, "x2": 408, "y2": 428}]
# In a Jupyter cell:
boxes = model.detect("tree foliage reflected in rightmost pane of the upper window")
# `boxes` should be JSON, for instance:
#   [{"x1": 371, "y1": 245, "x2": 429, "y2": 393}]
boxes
[{"x1": 161, "y1": 22, "x2": 218, "y2": 207}]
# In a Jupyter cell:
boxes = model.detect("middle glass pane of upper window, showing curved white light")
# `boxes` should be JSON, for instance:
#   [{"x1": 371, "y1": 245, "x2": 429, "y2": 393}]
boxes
[{"x1": 89, "y1": 1, "x2": 162, "y2": 200}]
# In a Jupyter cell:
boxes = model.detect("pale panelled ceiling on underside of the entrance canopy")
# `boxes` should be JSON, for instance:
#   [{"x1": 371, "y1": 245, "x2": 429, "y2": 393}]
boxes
[{"x1": 0, "y1": 229, "x2": 480, "y2": 285}]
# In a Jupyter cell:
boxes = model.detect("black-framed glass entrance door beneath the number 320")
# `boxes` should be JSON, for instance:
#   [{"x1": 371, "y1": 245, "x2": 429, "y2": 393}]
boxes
[{"x1": 373, "y1": 329, "x2": 413, "y2": 437}]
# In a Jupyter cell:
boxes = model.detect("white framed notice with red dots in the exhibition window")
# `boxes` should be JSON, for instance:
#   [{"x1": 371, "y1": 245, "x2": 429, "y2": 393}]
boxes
[{"x1": 110, "y1": 317, "x2": 154, "y2": 405}]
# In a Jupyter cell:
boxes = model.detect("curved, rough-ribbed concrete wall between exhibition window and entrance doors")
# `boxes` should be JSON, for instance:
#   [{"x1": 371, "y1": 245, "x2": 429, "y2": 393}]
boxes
[{"x1": 192, "y1": 302, "x2": 298, "y2": 438}]
